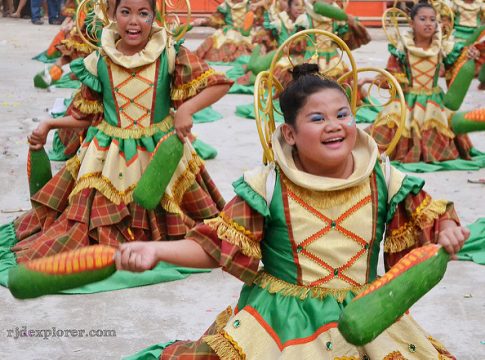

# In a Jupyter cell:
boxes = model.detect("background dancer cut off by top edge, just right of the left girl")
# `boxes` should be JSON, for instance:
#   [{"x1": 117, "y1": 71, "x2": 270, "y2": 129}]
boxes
[{"x1": 192, "y1": 0, "x2": 253, "y2": 62}]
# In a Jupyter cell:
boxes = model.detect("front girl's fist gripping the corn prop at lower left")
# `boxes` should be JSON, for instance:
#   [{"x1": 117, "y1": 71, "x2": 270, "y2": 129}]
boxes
[{"x1": 115, "y1": 241, "x2": 158, "y2": 272}]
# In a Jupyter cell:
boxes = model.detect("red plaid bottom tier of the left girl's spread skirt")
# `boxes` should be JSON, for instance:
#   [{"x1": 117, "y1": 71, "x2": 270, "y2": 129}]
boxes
[{"x1": 12, "y1": 162, "x2": 224, "y2": 262}]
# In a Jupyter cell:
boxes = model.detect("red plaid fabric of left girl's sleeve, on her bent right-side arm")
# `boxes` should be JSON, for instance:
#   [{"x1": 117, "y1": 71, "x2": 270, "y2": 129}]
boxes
[{"x1": 172, "y1": 46, "x2": 233, "y2": 108}]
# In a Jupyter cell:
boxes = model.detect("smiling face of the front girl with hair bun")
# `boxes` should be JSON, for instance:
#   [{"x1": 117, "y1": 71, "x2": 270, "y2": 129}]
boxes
[{"x1": 282, "y1": 89, "x2": 357, "y2": 176}]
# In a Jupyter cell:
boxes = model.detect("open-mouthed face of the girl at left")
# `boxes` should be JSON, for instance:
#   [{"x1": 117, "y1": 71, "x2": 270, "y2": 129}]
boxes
[{"x1": 115, "y1": 0, "x2": 154, "y2": 55}]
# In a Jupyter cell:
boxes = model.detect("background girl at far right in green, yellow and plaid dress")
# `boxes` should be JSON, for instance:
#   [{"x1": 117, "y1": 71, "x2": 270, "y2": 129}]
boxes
[{"x1": 367, "y1": 3, "x2": 478, "y2": 163}]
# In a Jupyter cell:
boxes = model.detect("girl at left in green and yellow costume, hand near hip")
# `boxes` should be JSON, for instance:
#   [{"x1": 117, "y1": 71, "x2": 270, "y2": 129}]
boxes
[{"x1": 0, "y1": 0, "x2": 231, "y2": 268}]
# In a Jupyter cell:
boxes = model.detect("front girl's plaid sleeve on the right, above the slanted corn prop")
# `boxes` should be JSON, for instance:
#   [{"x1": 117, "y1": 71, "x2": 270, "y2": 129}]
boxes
[{"x1": 384, "y1": 190, "x2": 460, "y2": 270}]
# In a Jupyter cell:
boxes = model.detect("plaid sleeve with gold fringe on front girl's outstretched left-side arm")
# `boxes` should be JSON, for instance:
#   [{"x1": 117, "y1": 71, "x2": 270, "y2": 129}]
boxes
[{"x1": 186, "y1": 196, "x2": 264, "y2": 284}]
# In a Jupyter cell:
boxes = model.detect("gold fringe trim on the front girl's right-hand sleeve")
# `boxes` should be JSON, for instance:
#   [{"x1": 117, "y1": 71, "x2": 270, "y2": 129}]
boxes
[{"x1": 384, "y1": 197, "x2": 448, "y2": 253}]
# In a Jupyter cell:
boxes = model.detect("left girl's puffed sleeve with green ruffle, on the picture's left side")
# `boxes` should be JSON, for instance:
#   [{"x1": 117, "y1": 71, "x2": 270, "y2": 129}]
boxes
[{"x1": 66, "y1": 52, "x2": 103, "y2": 124}]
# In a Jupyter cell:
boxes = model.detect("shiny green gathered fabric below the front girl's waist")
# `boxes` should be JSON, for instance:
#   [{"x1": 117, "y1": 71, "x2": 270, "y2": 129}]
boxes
[{"x1": 237, "y1": 285, "x2": 355, "y2": 343}]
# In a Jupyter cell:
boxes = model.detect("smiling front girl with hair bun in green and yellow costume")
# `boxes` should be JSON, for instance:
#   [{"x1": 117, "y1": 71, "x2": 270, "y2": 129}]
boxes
[{"x1": 117, "y1": 64, "x2": 468, "y2": 360}]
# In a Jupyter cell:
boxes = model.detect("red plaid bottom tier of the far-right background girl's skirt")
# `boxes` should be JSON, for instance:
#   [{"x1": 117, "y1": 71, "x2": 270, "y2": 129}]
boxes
[{"x1": 366, "y1": 124, "x2": 472, "y2": 163}]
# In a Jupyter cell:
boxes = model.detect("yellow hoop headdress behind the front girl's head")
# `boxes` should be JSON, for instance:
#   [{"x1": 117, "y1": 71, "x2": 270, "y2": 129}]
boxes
[{"x1": 254, "y1": 29, "x2": 406, "y2": 163}]
